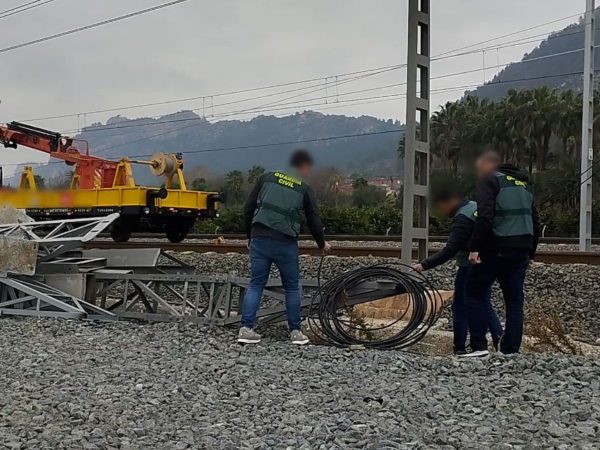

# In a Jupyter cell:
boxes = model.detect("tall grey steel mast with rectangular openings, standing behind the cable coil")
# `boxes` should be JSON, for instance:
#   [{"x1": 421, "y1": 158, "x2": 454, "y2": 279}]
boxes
[{"x1": 402, "y1": 0, "x2": 431, "y2": 264}]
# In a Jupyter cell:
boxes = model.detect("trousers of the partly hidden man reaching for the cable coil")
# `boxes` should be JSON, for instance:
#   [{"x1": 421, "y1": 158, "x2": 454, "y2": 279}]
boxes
[{"x1": 452, "y1": 267, "x2": 502, "y2": 351}]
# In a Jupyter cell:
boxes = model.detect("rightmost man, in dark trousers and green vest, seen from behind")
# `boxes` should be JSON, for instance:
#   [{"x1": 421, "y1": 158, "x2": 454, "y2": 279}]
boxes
[{"x1": 467, "y1": 151, "x2": 540, "y2": 356}]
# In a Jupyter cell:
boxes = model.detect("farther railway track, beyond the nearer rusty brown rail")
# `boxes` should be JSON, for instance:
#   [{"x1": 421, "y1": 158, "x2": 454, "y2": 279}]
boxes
[{"x1": 113, "y1": 233, "x2": 600, "y2": 245}]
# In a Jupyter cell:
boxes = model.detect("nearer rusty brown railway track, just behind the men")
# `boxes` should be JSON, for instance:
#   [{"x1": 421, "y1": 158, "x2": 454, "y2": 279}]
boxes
[{"x1": 86, "y1": 240, "x2": 600, "y2": 265}]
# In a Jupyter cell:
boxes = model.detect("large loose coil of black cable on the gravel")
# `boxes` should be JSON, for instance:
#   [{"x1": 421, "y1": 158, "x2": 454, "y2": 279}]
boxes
[{"x1": 308, "y1": 259, "x2": 442, "y2": 350}]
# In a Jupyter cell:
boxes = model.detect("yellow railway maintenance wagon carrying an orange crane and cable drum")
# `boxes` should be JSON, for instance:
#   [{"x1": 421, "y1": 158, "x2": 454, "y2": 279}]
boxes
[{"x1": 0, "y1": 122, "x2": 219, "y2": 242}]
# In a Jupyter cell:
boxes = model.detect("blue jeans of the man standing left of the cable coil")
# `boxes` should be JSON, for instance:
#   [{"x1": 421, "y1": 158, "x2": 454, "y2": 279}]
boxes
[{"x1": 242, "y1": 237, "x2": 301, "y2": 331}]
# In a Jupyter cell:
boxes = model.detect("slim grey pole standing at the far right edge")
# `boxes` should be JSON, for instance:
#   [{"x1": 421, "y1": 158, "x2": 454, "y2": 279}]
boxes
[{"x1": 579, "y1": 0, "x2": 596, "y2": 252}]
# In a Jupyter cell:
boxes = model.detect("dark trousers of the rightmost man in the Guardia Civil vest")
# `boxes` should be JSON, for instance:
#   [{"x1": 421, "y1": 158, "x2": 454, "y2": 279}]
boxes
[{"x1": 467, "y1": 251, "x2": 529, "y2": 354}]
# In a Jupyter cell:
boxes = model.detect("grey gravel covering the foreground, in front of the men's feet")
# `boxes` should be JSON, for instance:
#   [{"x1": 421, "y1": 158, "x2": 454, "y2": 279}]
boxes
[{"x1": 0, "y1": 318, "x2": 600, "y2": 449}]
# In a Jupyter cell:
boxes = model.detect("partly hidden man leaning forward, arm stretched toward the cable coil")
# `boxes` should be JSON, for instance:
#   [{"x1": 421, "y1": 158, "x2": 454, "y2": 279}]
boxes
[{"x1": 413, "y1": 190, "x2": 502, "y2": 356}]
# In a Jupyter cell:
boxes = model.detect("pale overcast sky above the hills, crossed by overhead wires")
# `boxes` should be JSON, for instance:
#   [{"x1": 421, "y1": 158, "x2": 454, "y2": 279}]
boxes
[{"x1": 0, "y1": 0, "x2": 585, "y2": 170}]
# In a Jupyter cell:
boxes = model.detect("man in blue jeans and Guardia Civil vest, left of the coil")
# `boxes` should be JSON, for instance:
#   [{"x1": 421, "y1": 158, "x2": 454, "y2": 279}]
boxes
[{"x1": 238, "y1": 150, "x2": 331, "y2": 345}]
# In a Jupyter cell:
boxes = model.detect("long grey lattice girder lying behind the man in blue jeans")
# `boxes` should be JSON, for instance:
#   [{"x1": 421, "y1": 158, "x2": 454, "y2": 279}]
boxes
[{"x1": 95, "y1": 271, "x2": 406, "y2": 325}]
